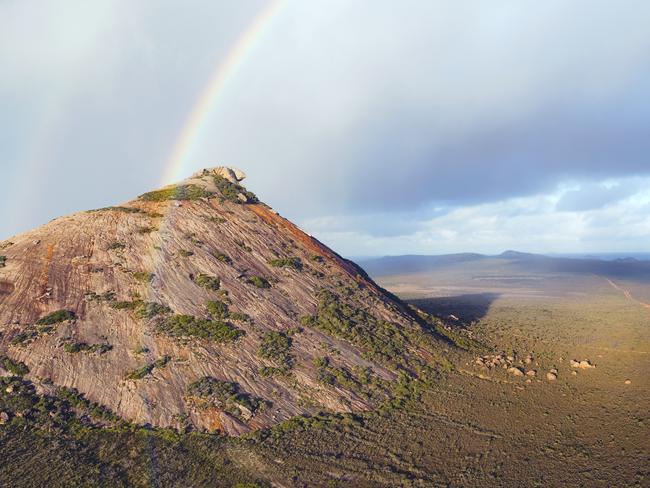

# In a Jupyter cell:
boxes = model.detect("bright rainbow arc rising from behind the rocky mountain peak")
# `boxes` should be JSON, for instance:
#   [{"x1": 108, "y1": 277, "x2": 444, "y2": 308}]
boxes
[{"x1": 162, "y1": 0, "x2": 286, "y2": 185}]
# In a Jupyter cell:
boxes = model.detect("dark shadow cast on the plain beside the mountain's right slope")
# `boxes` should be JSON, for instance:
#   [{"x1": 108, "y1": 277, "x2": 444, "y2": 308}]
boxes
[{"x1": 407, "y1": 292, "x2": 500, "y2": 324}]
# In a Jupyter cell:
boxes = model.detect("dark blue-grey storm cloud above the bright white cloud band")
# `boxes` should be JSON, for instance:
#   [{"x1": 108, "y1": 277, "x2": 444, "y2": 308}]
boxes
[{"x1": 349, "y1": 90, "x2": 650, "y2": 210}]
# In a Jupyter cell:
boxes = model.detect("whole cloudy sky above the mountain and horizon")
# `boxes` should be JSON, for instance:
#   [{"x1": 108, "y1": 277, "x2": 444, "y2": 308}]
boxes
[{"x1": 0, "y1": 0, "x2": 650, "y2": 256}]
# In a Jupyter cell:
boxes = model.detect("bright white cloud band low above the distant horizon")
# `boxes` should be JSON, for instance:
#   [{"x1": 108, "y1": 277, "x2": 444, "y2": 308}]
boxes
[{"x1": 303, "y1": 178, "x2": 650, "y2": 257}]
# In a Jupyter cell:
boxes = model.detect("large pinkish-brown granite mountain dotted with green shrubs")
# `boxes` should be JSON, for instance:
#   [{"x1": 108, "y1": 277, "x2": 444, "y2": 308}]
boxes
[{"x1": 0, "y1": 167, "x2": 442, "y2": 435}]
